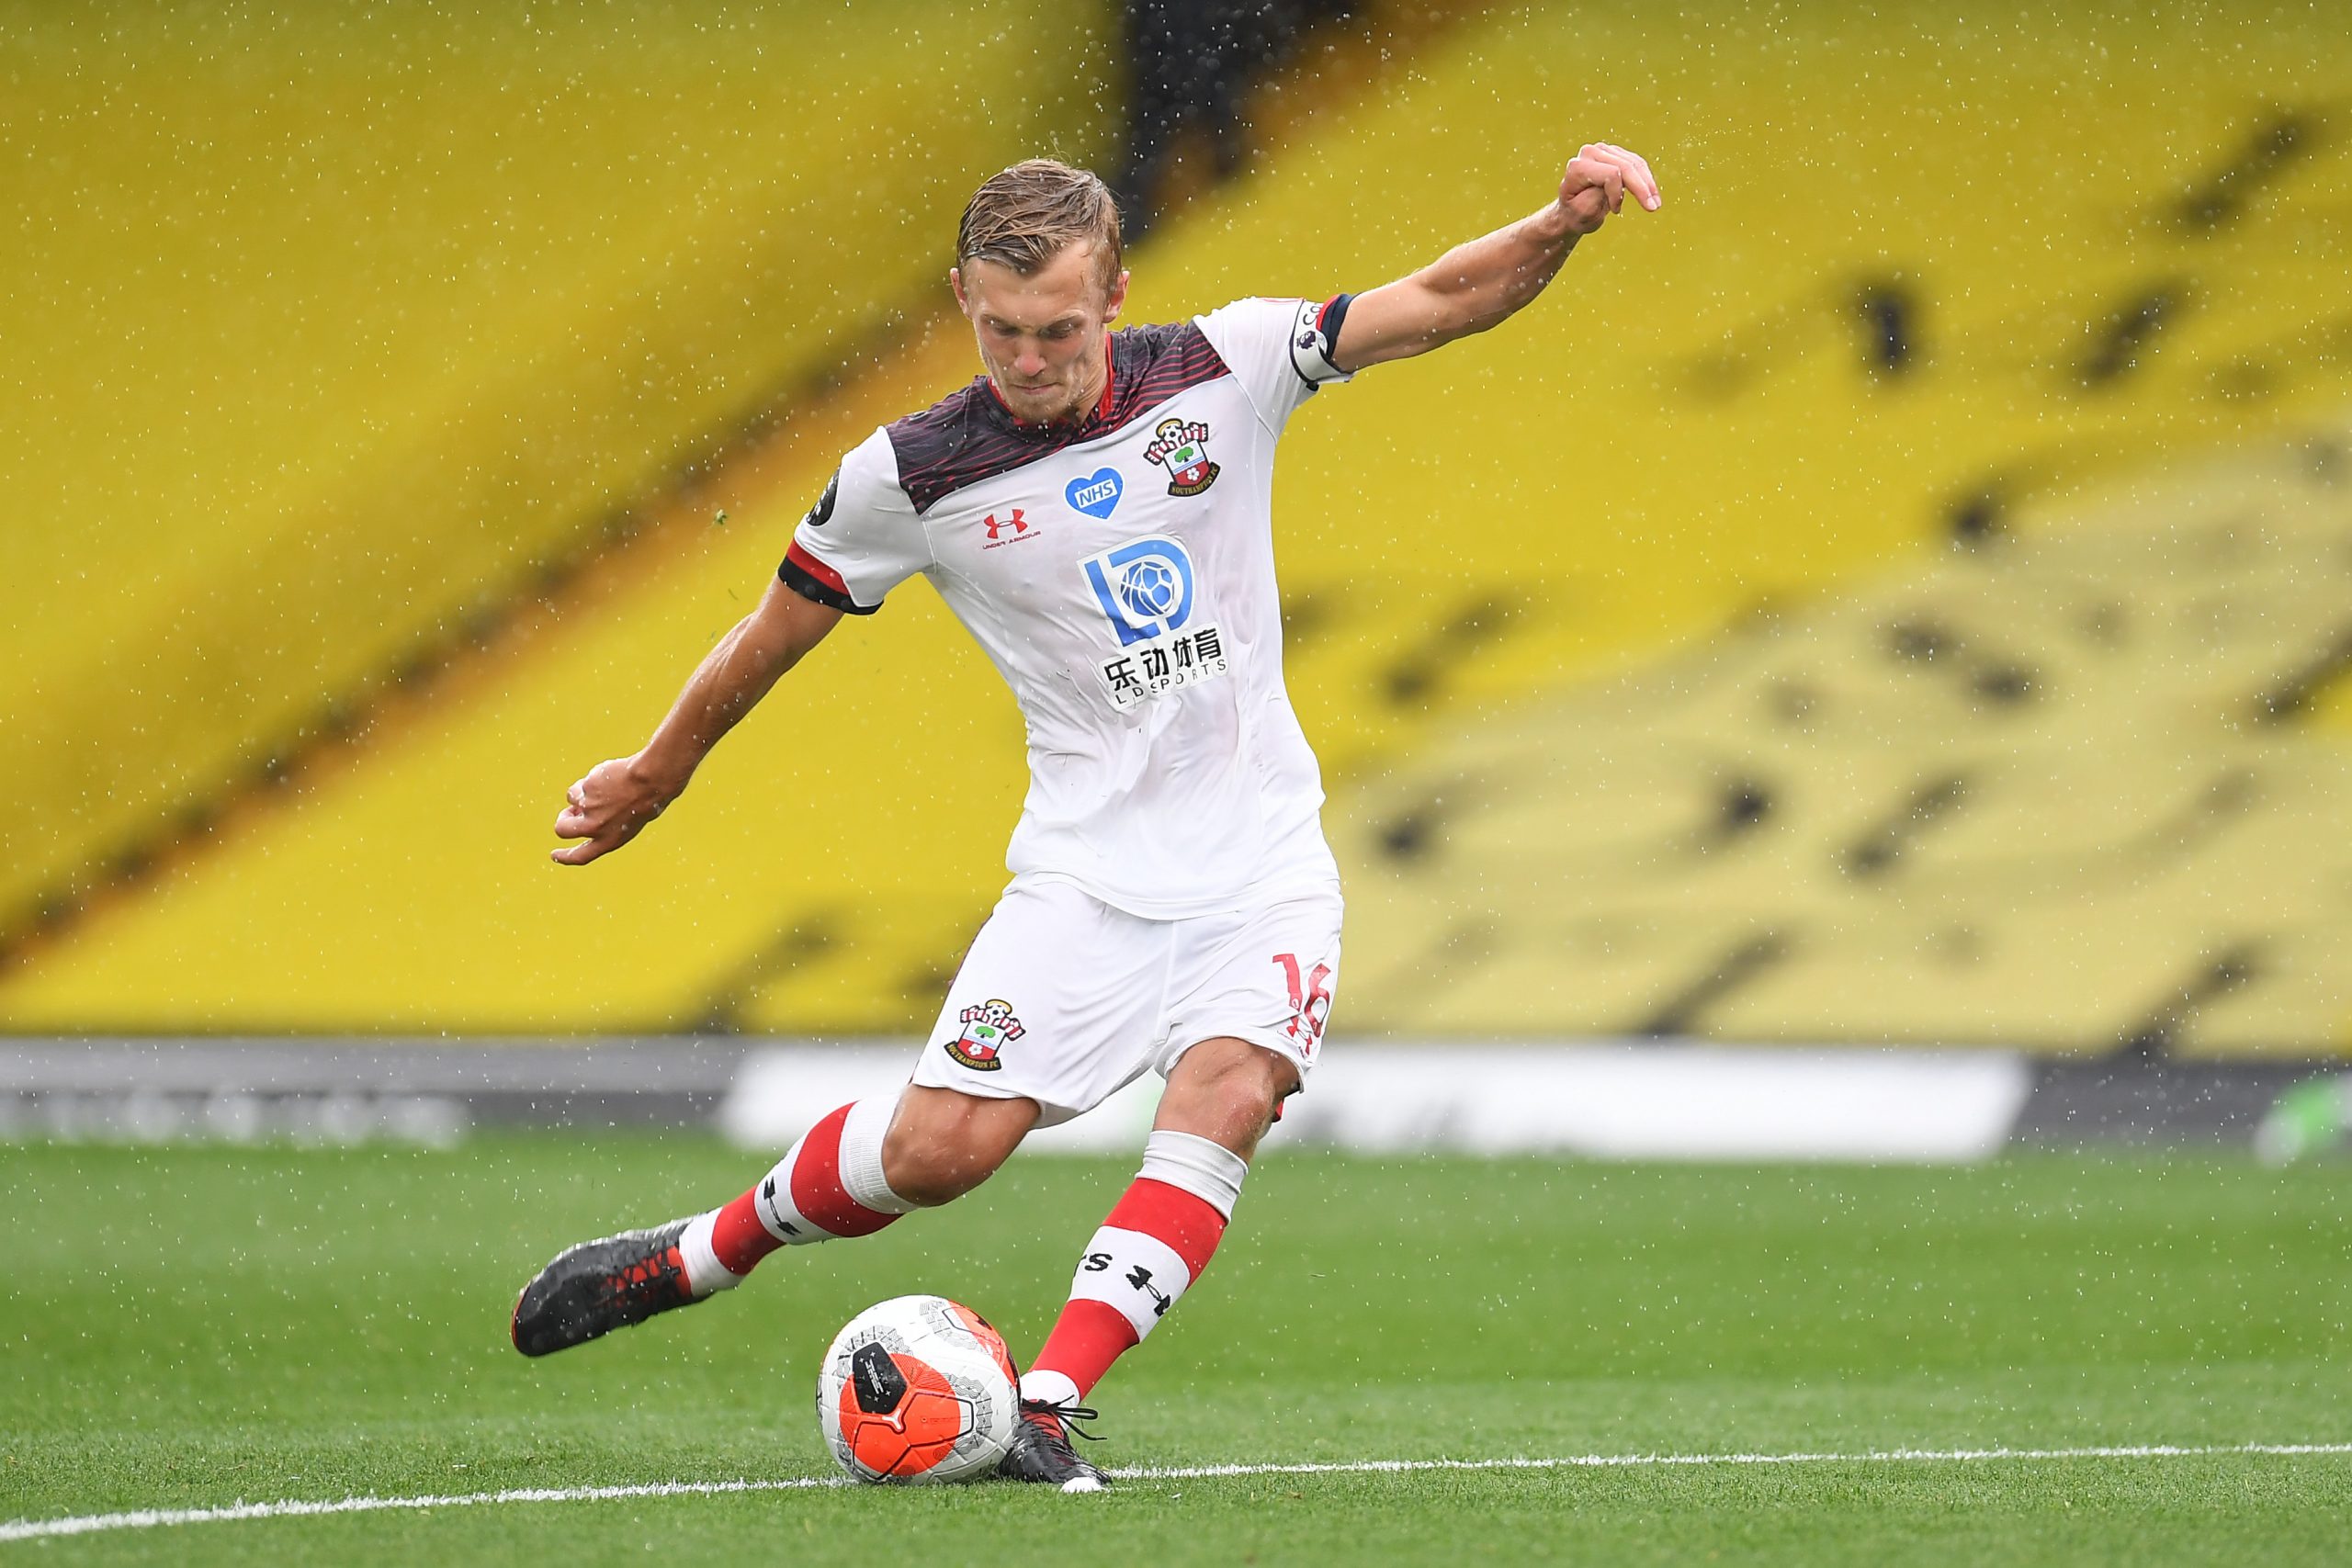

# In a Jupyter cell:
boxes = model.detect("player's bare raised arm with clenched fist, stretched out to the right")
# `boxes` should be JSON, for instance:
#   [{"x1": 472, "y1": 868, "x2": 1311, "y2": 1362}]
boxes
[{"x1": 1331, "y1": 141, "x2": 1660, "y2": 374}]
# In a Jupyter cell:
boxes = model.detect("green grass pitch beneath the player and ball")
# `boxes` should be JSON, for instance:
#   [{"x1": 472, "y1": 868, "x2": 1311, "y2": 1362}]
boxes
[{"x1": 0, "y1": 1134, "x2": 2352, "y2": 1568}]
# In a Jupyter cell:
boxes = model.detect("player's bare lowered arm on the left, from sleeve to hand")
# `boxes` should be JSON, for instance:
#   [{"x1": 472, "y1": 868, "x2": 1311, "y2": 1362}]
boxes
[{"x1": 548, "y1": 581, "x2": 842, "y2": 865}]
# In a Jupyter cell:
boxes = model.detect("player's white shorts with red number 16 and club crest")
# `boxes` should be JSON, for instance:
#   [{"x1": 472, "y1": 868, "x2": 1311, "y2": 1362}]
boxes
[{"x1": 915, "y1": 877, "x2": 1340, "y2": 1126}]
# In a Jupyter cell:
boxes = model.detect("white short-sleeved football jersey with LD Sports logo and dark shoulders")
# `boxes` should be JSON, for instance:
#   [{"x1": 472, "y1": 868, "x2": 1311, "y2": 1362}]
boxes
[{"x1": 778, "y1": 294, "x2": 1348, "y2": 919}]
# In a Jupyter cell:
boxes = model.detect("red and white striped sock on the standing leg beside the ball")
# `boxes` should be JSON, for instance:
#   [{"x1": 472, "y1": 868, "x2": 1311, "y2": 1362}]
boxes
[{"x1": 1021, "y1": 1131, "x2": 1249, "y2": 1404}]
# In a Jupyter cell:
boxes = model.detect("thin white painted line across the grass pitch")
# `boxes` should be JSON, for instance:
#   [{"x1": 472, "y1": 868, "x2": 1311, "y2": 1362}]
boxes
[{"x1": 0, "y1": 1443, "x2": 2352, "y2": 1542}]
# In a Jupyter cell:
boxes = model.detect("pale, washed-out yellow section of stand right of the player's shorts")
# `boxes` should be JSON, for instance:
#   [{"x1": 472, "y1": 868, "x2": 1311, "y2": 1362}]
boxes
[{"x1": 1348, "y1": 428, "x2": 2352, "y2": 1055}]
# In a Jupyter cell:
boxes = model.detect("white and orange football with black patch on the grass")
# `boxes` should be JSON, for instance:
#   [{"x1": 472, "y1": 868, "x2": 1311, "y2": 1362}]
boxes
[{"x1": 816, "y1": 1295, "x2": 1021, "y2": 1485}]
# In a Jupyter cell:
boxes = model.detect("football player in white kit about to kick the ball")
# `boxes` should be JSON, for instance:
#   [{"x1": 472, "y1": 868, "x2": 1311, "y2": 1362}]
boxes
[{"x1": 513, "y1": 143, "x2": 1658, "y2": 1491}]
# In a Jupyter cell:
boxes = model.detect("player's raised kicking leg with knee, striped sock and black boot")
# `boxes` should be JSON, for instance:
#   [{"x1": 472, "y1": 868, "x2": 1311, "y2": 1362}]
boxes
[{"x1": 511, "y1": 1086, "x2": 1037, "y2": 1357}]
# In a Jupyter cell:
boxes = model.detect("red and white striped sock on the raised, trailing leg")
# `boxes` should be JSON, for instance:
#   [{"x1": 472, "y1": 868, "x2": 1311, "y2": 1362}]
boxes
[{"x1": 677, "y1": 1098, "x2": 912, "y2": 1295}]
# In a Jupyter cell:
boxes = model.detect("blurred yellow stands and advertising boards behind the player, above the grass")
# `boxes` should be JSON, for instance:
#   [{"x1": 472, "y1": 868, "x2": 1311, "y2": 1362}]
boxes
[{"x1": 0, "y1": 0, "x2": 2352, "y2": 1159}]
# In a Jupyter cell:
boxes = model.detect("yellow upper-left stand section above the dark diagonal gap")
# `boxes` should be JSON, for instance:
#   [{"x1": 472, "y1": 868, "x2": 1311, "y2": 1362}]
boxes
[{"x1": 0, "y1": 0, "x2": 1110, "y2": 926}]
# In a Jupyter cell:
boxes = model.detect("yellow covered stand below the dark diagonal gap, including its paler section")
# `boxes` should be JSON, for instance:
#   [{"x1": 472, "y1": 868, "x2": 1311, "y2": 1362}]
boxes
[{"x1": 0, "y1": 3, "x2": 2352, "y2": 1051}]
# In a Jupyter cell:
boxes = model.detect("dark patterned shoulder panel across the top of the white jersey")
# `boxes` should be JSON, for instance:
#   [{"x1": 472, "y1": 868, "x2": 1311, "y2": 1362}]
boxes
[{"x1": 889, "y1": 322, "x2": 1226, "y2": 513}]
